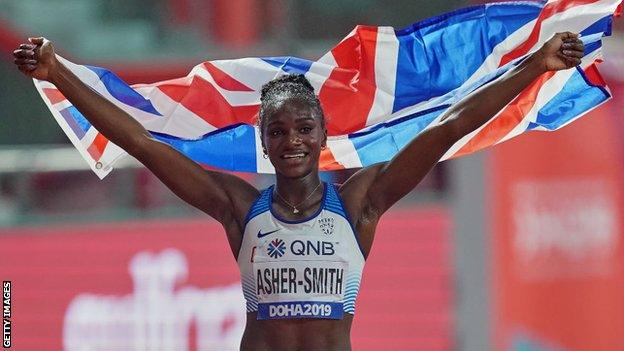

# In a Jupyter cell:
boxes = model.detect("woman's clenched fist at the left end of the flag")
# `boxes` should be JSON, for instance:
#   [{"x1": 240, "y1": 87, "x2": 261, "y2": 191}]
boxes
[{"x1": 13, "y1": 38, "x2": 59, "y2": 81}]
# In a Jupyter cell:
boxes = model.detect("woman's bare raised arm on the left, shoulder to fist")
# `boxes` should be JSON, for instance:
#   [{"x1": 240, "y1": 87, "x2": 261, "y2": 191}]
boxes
[{"x1": 14, "y1": 38, "x2": 258, "y2": 232}]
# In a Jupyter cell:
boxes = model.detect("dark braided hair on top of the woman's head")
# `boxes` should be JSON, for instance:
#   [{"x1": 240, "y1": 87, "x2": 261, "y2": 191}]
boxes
[{"x1": 258, "y1": 74, "x2": 325, "y2": 134}]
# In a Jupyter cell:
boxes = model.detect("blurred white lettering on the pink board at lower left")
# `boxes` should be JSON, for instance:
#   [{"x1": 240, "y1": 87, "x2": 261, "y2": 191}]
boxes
[{"x1": 63, "y1": 249, "x2": 245, "y2": 351}]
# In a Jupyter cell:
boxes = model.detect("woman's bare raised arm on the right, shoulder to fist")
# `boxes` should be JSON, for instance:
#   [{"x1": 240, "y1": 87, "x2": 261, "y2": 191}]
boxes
[{"x1": 341, "y1": 32, "x2": 583, "y2": 236}]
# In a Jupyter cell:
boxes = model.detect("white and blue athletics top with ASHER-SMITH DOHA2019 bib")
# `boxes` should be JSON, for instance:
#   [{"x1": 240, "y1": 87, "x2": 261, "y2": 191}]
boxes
[{"x1": 237, "y1": 184, "x2": 364, "y2": 319}]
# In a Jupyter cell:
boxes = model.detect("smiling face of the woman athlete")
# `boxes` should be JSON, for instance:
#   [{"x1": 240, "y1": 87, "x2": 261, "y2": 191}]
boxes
[{"x1": 262, "y1": 100, "x2": 327, "y2": 178}]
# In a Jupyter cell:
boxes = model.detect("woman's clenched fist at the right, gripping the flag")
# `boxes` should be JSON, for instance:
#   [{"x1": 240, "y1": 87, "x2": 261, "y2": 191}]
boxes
[{"x1": 535, "y1": 32, "x2": 585, "y2": 71}]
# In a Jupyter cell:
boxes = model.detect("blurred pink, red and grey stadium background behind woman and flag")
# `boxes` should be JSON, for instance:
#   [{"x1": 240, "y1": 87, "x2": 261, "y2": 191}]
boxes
[{"x1": 0, "y1": 0, "x2": 624, "y2": 351}]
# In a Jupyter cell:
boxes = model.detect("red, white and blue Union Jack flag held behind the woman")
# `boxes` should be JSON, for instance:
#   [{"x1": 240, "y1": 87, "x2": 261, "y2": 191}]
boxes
[{"x1": 35, "y1": 0, "x2": 622, "y2": 178}]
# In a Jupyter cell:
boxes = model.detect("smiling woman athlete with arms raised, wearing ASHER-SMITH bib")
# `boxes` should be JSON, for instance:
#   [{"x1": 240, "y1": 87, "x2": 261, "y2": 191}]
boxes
[{"x1": 14, "y1": 32, "x2": 584, "y2": 350}]
